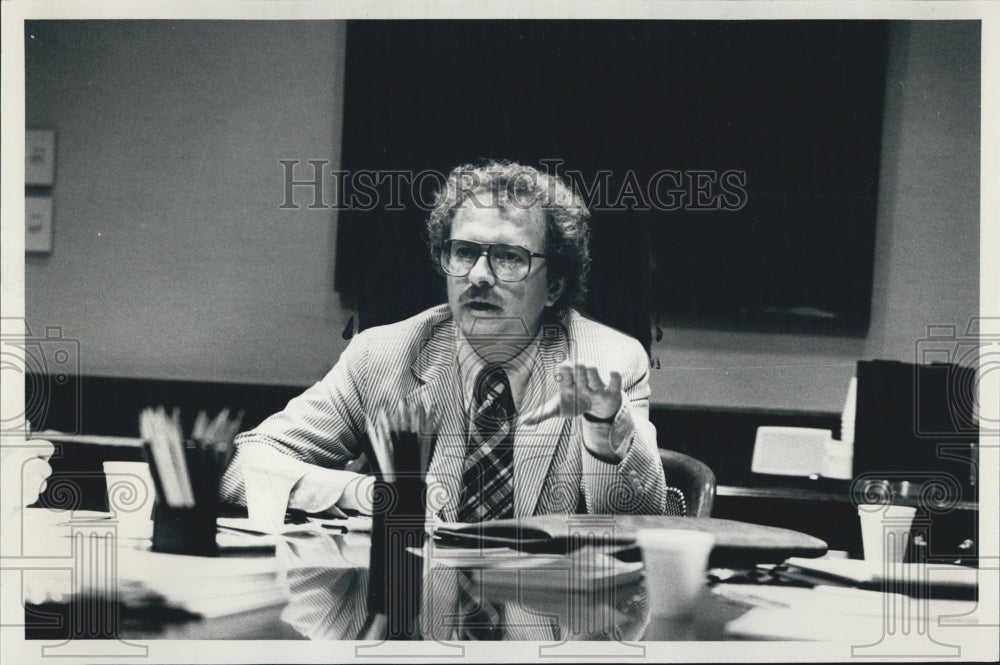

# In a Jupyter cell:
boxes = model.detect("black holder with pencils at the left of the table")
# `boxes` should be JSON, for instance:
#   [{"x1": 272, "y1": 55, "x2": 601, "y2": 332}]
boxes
[{"x1": 143, "y1": 443, "x2": 219, "y2": 556}]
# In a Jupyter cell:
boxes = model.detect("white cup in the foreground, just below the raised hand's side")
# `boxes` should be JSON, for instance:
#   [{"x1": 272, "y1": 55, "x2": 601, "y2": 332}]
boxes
[{"x1": 636, "y1": 529, "x2": 715, "y2": 617}]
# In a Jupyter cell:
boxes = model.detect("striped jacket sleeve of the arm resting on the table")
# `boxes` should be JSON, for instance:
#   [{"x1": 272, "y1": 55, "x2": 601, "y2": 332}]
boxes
[{"x1": 219, "y1": 333, "x2": 368, "y2": 504}]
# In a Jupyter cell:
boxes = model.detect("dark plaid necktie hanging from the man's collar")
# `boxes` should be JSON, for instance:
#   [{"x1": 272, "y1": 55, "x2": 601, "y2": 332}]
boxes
[{"x1": 458, "y1": 364, "x2": 515, "y2": 522}]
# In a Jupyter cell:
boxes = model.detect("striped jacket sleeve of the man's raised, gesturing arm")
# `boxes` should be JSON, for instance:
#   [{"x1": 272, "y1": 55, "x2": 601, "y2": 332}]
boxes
[{"x1": 580, "y1": 342, "x2": 667, "y2": 515}]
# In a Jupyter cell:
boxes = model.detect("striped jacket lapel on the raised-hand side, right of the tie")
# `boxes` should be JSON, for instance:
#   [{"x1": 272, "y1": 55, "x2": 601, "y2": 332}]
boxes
[{"x1": 514, "y1": 326, "x2": 568, "y2": 517}]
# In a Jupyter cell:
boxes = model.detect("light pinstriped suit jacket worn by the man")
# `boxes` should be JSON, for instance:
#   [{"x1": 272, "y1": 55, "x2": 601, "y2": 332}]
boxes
[{"x1": 221, "y1": 305, "x2": 667, "y2": 521}]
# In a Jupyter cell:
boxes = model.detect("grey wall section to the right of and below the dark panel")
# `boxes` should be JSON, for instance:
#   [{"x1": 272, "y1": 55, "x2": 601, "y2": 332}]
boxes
[{"x1": 652, "y1": 22, "x2": 980, "y2": 411}]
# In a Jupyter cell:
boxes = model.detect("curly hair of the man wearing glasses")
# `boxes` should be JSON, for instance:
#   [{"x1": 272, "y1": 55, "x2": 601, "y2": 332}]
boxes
[{"x1": 427, "y1": 161, "x2": 590, "y2": 318}]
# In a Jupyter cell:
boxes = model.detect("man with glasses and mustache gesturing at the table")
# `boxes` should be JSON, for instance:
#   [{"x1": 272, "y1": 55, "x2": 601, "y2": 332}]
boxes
[{"x1": 222, "y1": 162, "x2": 676, "y2": 521}]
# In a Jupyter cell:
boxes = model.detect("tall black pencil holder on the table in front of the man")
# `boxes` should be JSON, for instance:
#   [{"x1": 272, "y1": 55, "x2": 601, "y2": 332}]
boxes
[{"x1": 368, "y1": 474, "x2": 425, "y2": 640}]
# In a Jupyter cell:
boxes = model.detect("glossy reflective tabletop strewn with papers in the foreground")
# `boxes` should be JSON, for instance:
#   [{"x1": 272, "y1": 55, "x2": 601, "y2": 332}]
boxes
[{"x1": 15, "y1": 509, "x2": 976, "y2": 644}]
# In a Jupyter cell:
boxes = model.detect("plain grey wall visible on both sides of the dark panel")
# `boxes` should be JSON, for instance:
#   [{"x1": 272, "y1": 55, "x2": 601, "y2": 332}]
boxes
[{"x1": 26, "y1": 22, "x2": 980, "y2": 411}]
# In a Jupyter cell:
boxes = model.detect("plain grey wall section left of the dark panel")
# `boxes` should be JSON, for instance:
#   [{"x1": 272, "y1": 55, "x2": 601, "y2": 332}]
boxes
[{"x1": 25, "y1": 21, "x2": 348, "y2": 384}]
